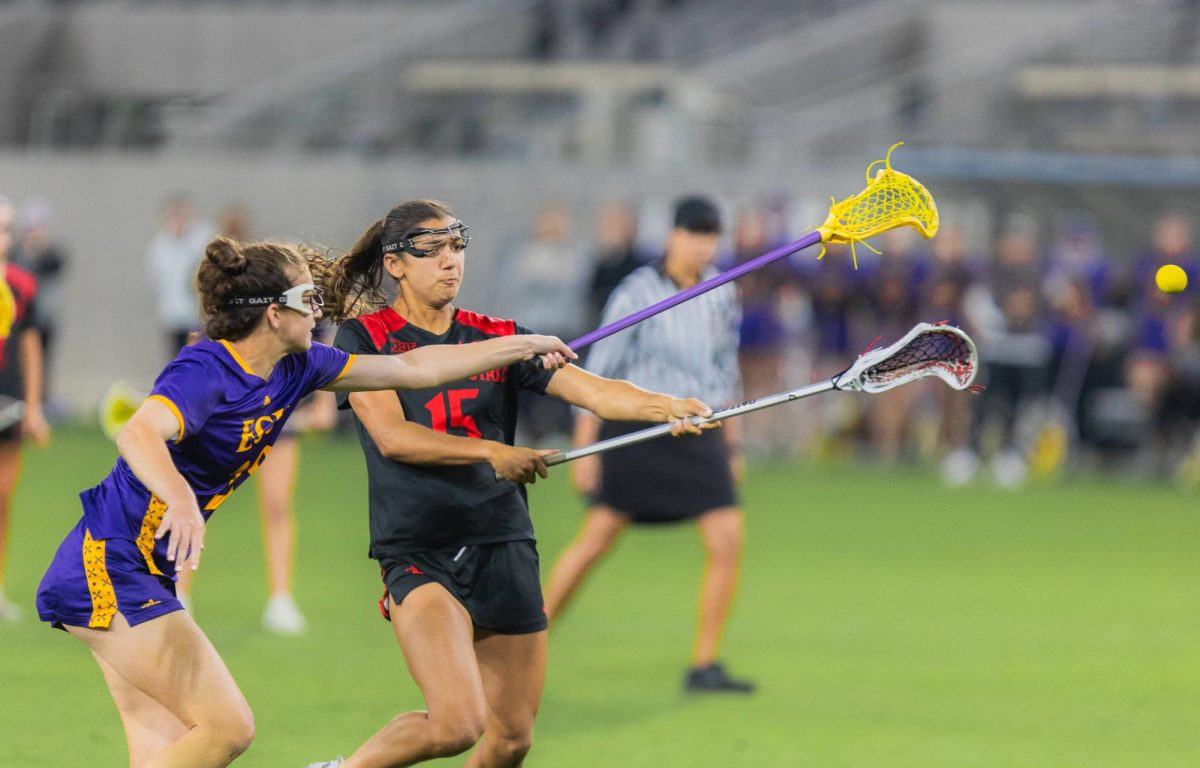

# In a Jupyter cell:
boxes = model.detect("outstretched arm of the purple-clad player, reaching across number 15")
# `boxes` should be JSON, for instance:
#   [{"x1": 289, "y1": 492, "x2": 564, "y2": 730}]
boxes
[{"x1": 325, "y1": 335, "x2": 576, "y2": 392}]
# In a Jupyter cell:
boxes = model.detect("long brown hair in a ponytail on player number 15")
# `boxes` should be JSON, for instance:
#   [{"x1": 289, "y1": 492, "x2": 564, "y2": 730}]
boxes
[{"x1": 311, "y1": 199, "x2": 454, "y2": 323}]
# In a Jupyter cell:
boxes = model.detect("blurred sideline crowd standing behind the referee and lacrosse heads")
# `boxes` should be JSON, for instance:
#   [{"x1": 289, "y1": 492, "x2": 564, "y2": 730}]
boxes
[{"x1": 494, "y1": 203, "x2": 1200, "y2": 487}]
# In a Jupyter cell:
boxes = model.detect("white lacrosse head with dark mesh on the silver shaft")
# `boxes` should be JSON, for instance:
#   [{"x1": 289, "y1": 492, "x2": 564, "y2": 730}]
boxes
[{"x1": 834, "y1": 323, "x2": 979, "y2": 392}]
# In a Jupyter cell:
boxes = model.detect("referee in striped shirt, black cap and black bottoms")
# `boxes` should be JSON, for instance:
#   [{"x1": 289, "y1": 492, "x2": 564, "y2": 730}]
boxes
[{"x1": 546, "y1": 197, "x2": 754, "y2": 694}]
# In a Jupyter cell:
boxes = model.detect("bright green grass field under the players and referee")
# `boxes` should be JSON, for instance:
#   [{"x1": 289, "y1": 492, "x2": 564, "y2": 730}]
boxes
[{"x1": 0, "y1": 430, "x2": 1200, "y2": 768}]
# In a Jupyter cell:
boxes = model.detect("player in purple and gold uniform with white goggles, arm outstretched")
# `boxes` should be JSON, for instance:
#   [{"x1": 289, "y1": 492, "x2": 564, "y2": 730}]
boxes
[{"x1": 30, "y1": 238, "x2": 574, "y2": 767}]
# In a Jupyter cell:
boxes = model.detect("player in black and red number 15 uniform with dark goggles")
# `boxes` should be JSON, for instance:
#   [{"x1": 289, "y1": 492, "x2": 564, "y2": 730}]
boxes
[{"x1": 302, "y1": 200, "x2": 710, "y2": 768}]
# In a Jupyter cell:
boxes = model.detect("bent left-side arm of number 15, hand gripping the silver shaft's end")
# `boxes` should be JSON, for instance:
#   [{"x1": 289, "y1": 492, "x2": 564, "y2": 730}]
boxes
[{"x1": 350, "y1": 392, "x2": 553, "y2": 482}]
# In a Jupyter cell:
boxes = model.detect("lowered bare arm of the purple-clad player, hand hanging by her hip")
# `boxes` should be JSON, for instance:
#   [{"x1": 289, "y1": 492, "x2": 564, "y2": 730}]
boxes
[{"x1": 116, "y1": 400, "x2": 204, "y2": 570}]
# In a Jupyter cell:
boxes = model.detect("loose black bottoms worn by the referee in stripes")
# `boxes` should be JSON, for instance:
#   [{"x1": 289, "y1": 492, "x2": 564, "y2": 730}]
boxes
[{"x1": 593, "y1": 421, "x2": 738, "y2": 523}]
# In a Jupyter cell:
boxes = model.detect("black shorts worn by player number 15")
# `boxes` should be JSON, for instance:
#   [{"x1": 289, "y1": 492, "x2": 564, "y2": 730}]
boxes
[{"x1": 379, "y1": 539, "x2": 547, "y2": 635}]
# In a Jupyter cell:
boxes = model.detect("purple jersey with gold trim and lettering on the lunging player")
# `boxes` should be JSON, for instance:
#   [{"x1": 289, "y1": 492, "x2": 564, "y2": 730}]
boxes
[{"x1": 79, "y1": 341, "x2": 354, "y2": 571}]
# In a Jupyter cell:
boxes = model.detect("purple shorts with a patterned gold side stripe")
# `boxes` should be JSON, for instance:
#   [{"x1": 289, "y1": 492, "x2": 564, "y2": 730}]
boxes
[{"x1": 37, "y1": 520, "x2": 184, "y2": 629}]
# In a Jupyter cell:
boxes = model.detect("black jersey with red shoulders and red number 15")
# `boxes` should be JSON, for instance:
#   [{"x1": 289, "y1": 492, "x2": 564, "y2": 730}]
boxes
[{"x1": 334, "y1": 307, "x2": 554, "y2": 558}]
